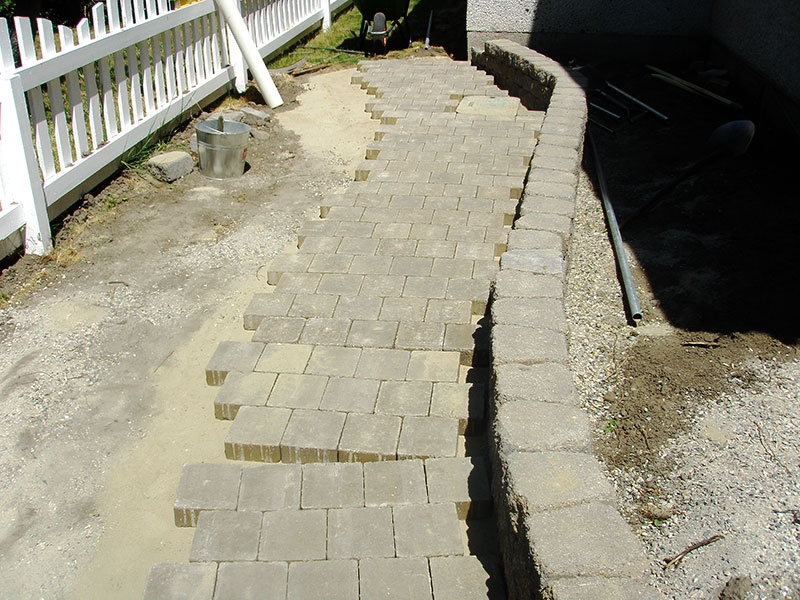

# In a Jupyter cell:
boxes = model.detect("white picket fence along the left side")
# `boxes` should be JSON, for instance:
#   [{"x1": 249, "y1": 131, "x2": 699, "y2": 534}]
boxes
[{"x1": 0, "y1": 0, "x2": 352, "y2": 258}]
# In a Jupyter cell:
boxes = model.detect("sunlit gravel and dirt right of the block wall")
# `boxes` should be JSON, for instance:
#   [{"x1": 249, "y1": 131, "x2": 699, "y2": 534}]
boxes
[{"x1": 566, "y1": 165, "x2": 800, "y2": 600}]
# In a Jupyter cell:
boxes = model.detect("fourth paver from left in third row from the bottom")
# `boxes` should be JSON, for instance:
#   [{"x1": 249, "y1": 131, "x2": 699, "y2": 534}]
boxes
[{"x1": 364, "y1": 459, "x2": 428, "y2": 506}]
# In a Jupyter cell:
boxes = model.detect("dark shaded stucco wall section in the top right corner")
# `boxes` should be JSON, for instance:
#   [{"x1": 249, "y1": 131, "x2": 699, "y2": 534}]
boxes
[{"x1": 711, "y1": 0, "x2": 800, "y2": 102}]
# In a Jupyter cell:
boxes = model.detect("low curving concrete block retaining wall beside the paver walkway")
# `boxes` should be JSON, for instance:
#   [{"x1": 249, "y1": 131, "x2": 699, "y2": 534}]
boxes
[{"x1": 473, "y1": 40, "x2": 661, "y2": 600}]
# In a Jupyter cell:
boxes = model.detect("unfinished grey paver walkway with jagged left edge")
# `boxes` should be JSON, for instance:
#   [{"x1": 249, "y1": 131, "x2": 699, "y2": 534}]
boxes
[{"x1": 145, "y1": 59, "x2": 542, "y2": 600}]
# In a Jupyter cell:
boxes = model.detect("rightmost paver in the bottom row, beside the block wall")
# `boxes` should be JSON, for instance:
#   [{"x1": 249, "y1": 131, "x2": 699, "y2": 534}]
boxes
[{"x1": 430, "y1": 556, "x2": 506, "y2": 600}]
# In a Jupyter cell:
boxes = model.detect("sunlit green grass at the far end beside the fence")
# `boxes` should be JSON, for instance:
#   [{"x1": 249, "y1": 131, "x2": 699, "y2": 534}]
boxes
[{"x1": 267, "y1": 0, "x2": 422, "y2": 69}]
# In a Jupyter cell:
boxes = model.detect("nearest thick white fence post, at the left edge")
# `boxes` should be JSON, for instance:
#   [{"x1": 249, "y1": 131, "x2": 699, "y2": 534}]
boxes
[{"x1": 0, "y1": 75, "x2": 53, "y2": 254}]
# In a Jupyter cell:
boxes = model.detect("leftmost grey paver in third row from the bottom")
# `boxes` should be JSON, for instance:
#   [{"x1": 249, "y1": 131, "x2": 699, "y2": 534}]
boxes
[{"x1": 173, "y1": 463, "x2": 242, "y2": 527}]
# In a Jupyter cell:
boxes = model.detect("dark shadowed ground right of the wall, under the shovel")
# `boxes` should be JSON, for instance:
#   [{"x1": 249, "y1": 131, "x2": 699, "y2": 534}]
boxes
[{"x1": 584, "y1": 66, "x2": 800, "y2": 344}]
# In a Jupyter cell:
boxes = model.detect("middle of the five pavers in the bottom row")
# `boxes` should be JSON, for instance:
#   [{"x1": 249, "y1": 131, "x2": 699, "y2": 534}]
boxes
[{"x1": 286, "y1": 560, "x2": 358, "y2": 600}]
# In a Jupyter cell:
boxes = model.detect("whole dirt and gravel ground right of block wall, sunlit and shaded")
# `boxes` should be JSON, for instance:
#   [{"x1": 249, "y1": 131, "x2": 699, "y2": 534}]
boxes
[{"x1": 568, "y1": 59, "x2": 800, "y2": 600}]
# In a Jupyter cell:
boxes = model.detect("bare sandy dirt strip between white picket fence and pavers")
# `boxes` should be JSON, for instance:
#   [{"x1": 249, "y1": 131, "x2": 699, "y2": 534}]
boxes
[{"x1": 0, "y1": 71, "x2": 376, "y2": 599}]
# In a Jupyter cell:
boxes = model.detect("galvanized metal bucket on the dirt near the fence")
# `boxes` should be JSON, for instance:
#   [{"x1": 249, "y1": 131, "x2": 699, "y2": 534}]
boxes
[{"x1": 195, "y1": 119, "x2": 250, "y2": 179}]
